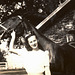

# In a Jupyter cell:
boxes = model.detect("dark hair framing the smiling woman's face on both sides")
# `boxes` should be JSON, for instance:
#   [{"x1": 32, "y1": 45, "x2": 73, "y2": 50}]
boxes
[{"x1": 25, "y1": 33, "x2": 43, "y2": 51}]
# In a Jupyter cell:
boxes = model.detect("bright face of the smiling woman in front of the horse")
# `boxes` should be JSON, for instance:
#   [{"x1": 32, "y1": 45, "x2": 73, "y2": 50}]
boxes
[{"x1": 28, "y1": 35, "x2": 38, "y2": 50}]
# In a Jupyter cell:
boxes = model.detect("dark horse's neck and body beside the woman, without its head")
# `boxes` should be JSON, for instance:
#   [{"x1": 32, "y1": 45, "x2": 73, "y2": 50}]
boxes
[{"x1": 31, "y1": 25, "x2": 75, "y2": 75}]
